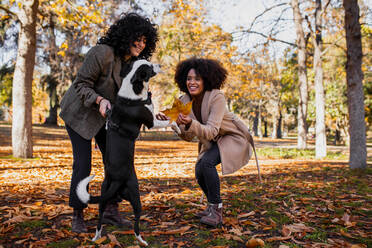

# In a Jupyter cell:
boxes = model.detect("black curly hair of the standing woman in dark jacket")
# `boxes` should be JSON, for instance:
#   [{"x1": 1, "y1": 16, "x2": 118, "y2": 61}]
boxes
[{"x1": 97, "y1": 13, "x2": 158, "y2": 59}]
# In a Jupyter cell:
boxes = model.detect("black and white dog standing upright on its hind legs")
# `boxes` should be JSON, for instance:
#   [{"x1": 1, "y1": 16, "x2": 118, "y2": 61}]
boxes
[{"x1": 77, "y1": 60, "x2": 180, "y2": 246}]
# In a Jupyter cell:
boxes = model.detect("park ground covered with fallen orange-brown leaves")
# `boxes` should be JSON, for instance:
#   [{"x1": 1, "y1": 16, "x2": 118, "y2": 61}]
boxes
[{"x1": 0, "y1": 123, "x2": 372, "y2": 248}]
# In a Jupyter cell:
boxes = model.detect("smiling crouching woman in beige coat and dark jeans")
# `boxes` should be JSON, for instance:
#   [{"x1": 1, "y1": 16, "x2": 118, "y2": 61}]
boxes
[{"x1": 158, "y1": 58, "x2": 252, "y2": 226}]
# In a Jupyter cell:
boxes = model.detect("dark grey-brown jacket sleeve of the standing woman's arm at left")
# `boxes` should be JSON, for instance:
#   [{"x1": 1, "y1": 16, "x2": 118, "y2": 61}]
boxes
[{"x1": 73, "y1": 45, "x2": 113, "y2": 108}]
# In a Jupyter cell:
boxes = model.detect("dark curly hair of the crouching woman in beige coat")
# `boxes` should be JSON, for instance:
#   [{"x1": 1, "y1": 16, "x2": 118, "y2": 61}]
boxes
[{"x1": 174, "y1": 57, "x2": 228, "y2": 95}]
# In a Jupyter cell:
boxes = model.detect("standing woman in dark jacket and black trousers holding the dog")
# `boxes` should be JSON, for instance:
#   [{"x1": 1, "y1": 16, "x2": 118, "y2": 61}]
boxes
[{"x1": 60, "y1": 13, "x2": 158, "y2": 233}]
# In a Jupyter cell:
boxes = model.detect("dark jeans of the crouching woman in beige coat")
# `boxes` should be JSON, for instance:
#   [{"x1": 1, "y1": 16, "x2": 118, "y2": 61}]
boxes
[{"x1": 195, "y1": 142, "x2": 221, "y2": 204}]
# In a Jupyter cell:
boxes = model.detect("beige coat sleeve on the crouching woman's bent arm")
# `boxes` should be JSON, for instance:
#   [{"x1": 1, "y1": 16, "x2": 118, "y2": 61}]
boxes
[{"x1": 186, "y1": 92, "x2": 226, "y2": 140}]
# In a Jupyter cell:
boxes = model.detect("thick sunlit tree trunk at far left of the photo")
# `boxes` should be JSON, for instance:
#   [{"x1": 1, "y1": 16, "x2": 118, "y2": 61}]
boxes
[{"x1": 12, "y1": 0, "x2": 39, "y2": 158}]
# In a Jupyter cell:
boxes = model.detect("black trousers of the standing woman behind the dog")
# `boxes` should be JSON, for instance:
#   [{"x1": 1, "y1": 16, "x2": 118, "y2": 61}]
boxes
[{"x1": 66, "y1": 125, "x2": 106, "y2": 209}]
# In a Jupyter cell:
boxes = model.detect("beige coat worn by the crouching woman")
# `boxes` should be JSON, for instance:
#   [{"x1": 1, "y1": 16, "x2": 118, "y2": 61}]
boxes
[{"x1": 180, "y1": 89, "x2": 252, "y2": 175}]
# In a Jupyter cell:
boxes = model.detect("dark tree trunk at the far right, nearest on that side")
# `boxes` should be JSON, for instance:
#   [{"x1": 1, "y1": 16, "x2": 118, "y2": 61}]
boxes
[{"x1": 343, "y1": 0, "x2": 367, "y2": 169}]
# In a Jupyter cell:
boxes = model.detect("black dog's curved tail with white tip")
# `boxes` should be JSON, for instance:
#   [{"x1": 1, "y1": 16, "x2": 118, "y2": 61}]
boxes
[{"x1": 76, "y1": 175, "x2": 120, "y2": 204}]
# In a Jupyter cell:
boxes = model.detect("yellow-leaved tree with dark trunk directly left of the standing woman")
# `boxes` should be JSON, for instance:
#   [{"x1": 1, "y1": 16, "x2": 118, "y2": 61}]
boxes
[{"x1": 39, "y1": 0, "x2": 109, "y2": 125}]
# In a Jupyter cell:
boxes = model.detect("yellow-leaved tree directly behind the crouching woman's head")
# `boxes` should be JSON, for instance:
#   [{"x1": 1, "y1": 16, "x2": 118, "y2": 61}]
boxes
[{"x1": 151, "y1": 0, "x2": 236, "y2": 104}]
